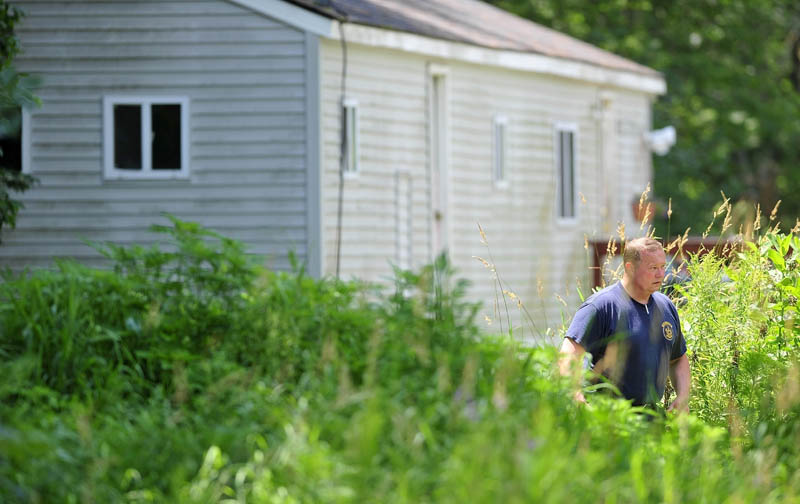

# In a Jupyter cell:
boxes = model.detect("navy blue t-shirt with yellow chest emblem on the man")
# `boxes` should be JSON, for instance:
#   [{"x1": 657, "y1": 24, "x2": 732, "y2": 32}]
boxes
[{"x1": 566, "y1": 282, "x2": 686, "y2": 405}]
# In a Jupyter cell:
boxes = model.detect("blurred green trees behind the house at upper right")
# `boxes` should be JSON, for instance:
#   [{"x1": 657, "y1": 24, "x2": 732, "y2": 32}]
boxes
[{"x1": 491, "y1": 0, "x2": 800, "y2": 232}]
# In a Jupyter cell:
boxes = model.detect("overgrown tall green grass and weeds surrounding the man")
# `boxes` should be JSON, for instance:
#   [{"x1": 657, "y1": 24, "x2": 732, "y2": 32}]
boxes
[{"x1": 0, "y1": 215, "x2": 800, "y2": 503}]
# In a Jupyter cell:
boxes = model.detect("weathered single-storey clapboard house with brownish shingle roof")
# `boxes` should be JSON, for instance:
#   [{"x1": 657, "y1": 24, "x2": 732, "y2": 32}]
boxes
[{"x1": 0, "y1": 0, "x2": 665, "y2": 334}]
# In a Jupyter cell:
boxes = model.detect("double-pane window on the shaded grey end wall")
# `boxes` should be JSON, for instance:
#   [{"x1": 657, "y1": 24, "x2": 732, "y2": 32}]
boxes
[{"x1": 103, "y1": 97, "x2": 189, "y2": 179}]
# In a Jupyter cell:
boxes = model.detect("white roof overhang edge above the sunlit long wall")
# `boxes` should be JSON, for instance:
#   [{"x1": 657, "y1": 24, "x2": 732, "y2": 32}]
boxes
[{"x1": 328, "y1": 21, "x2": 667, "y2": 95}]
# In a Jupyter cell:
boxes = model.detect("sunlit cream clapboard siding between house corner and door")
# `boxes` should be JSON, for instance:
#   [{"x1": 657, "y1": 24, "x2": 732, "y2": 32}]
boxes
[{"x1": 321, "y1": 41, "x2": 430, "y2": 281}]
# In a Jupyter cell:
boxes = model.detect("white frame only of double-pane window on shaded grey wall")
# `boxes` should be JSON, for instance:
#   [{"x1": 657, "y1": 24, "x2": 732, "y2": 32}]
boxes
[{"x1": 103, "y1": 95, "x2": 190, "y2": 180}]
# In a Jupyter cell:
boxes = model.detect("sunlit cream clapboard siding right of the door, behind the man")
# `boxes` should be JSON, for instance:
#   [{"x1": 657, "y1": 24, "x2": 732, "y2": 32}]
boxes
[{"x1": 450, "y1": 64, "x2": 650, "y2": 330}]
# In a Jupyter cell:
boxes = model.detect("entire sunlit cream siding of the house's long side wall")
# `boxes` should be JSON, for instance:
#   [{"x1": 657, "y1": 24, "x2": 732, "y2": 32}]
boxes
[{"x1": 322, "y1": 37, "x2": 650, "y2": 338}]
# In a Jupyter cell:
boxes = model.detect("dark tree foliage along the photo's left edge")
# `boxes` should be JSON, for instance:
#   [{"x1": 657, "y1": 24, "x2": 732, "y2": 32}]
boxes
[{"x1": 0, "y1": 0, "x2": 39, "y2": 244}]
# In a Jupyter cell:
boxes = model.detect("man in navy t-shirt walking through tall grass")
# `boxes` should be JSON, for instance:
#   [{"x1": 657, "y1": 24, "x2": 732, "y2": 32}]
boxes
[{"x1": 561, "y1": 238, "x2": 691, "y2": 411}]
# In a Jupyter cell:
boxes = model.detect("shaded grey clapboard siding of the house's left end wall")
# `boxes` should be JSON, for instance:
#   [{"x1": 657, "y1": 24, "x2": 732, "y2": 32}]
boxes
[{"x1": 5, "y1": 0, "x2": 316, "y2": 269}]
